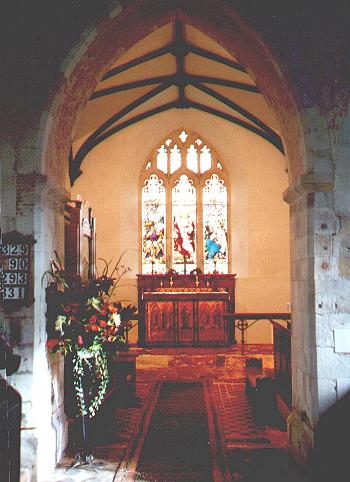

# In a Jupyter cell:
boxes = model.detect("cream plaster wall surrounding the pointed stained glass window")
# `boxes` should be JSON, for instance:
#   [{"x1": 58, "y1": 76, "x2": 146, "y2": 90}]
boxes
[{"x1": 72, "y1": 110, "x2": 290, "y2": 343}]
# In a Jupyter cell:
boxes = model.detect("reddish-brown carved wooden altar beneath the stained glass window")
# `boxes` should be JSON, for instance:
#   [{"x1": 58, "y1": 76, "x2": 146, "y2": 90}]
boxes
[{"x1": 138, "y1": 273, "x2": 235, "y2": 346}]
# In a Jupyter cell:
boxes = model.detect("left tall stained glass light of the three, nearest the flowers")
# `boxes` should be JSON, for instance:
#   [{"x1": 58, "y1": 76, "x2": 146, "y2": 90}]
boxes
[{"x1": 142, "y1": 174, "x2": 166, "y2": 274}]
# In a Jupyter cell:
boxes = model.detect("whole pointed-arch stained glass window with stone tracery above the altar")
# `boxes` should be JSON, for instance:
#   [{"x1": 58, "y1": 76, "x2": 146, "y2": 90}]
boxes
[{"x1": 141, "y1": 129, "x2": 229, "y2": 274}]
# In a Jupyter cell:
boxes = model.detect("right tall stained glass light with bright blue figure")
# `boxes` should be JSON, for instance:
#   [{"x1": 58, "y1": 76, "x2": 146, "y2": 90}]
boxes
[{"x1": 203, "y1": 174, "x2": 228, "y2": 273}]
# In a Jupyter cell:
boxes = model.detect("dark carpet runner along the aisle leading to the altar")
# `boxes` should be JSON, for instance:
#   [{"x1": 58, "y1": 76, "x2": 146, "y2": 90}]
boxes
[{"x1": 135, "y1": 382, "x2": 212, "y2": 482}]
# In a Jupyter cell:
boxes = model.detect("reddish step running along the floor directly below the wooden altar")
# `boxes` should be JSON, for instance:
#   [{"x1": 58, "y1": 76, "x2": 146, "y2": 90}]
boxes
[{"x1": 131, "y1": 345, "x2": 274, "y2": 370}]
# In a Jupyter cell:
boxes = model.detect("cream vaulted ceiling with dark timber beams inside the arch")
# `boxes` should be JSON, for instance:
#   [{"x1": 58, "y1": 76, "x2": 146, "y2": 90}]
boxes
[{"x1": 70, "y1": 21, "x2": 283, "y2": 183}]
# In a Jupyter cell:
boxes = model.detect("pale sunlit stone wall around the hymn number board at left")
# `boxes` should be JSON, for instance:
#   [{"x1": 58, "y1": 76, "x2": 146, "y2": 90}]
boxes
[{"x1": 1, "y1": 156, "x2": 67, "y2": 481}]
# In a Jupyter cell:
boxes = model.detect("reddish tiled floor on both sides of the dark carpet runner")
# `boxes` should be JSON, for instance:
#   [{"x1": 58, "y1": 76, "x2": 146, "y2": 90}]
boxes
[{"x1": 48, "y1": 347, "x2": 307, "y2": 482}]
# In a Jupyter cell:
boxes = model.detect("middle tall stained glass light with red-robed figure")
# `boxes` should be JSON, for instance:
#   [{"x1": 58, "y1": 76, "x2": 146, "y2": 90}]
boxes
[{"x1": 172, "y1": 175, "x2": 196, "y2": 273}]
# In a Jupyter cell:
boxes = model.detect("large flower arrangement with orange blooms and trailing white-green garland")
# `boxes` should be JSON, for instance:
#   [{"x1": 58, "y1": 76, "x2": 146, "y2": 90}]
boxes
[{"x1": 45, "y1": 254, "x2": 136, "y2": 417}]
